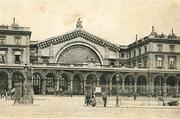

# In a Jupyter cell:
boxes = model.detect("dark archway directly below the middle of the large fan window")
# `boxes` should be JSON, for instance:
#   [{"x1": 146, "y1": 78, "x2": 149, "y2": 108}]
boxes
[{"x1": 73, "y1": 73, "x2": 84, "y2": 95}]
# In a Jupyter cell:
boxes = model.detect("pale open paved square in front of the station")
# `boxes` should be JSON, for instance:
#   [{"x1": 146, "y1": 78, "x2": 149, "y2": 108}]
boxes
[{"x1": 0, "y1": 96, "x2": 180, "y2": 119}]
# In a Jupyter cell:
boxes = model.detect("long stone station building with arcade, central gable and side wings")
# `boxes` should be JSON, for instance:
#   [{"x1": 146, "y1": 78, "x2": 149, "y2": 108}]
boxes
[{"x1": 0, "y1": 19, "x2": 180, "y2": 96}]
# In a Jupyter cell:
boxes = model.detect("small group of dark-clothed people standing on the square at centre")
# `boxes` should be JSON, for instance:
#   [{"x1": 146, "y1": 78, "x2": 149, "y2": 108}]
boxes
[{"x1": 85, "y1": 93, "x2": 107, "y2": 107}]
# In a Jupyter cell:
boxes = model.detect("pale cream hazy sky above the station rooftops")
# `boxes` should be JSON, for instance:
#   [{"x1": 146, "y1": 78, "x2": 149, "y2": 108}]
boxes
[{"x1": 0, "y1": 0, "x2": 180, "y2": 45}]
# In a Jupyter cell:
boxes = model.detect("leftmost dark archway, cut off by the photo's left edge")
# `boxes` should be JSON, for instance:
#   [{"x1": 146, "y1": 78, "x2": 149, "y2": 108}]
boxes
[{"x1": 0, "y1": 71, "x2": 8, "y2": 91}]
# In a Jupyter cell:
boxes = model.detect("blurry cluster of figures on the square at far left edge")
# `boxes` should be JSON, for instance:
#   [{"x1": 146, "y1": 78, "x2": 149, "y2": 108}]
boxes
[{"x1": 0, "y1": 88, "x2": 15, "y2": 100}]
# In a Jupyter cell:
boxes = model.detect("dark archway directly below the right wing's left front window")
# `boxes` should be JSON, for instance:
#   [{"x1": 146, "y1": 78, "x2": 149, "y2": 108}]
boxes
[{"x1": 154, "y1": 75, "x2": 165, "y2": 95}]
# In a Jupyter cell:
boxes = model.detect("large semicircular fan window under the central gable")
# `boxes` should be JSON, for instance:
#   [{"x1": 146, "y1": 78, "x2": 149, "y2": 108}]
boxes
[{"x1": 57, "y1": 44, "x2": 101, "y2": 64}]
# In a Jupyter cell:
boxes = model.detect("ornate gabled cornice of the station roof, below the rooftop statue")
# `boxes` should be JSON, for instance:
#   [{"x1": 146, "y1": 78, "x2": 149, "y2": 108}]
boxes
[{"x1": 37, "y1": 29, "x2": 120, "y2": 51}]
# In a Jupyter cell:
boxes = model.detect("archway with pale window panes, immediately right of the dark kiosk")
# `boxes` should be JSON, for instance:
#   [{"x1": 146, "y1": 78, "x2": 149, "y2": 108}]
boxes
[{"x1": 33, "y1": 73, "x2": 42, "y2": 94}]
